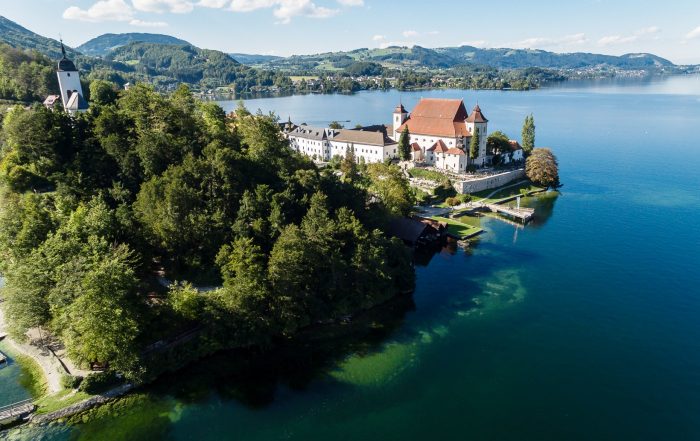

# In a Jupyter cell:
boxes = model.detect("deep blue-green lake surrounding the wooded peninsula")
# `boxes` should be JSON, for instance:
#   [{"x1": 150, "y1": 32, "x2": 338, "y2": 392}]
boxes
[{"x1": 5, "y1": 77, "x2": 700, "y2": 441}]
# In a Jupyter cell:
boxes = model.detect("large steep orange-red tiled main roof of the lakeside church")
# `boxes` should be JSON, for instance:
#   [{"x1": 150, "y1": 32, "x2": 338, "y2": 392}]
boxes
[{"x1": 397, "y1": 98, "x2": 470, "y2": 138}]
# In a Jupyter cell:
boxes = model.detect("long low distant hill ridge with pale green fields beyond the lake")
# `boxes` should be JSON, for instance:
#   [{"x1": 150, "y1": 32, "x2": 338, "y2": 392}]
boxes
[{"x1": 239, "y1": 46, "x2": 674, "y2": 71}]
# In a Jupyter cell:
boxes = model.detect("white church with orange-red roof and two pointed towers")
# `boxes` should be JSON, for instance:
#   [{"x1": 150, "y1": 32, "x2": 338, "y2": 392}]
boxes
[{"x1": 393, "y1": 98, "x2": 491, "y2": 173}]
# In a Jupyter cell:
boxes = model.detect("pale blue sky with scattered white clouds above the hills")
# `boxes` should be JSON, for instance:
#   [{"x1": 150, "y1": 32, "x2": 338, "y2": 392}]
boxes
[{"x1": 0, "y1": 0, "x2": 700, "y2": 64}]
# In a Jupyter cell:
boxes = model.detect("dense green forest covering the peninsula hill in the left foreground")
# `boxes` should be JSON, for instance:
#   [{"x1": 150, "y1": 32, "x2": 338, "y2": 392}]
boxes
[{"x1": 0, "y1": 81, "x2": 414, "y2": 379}]
